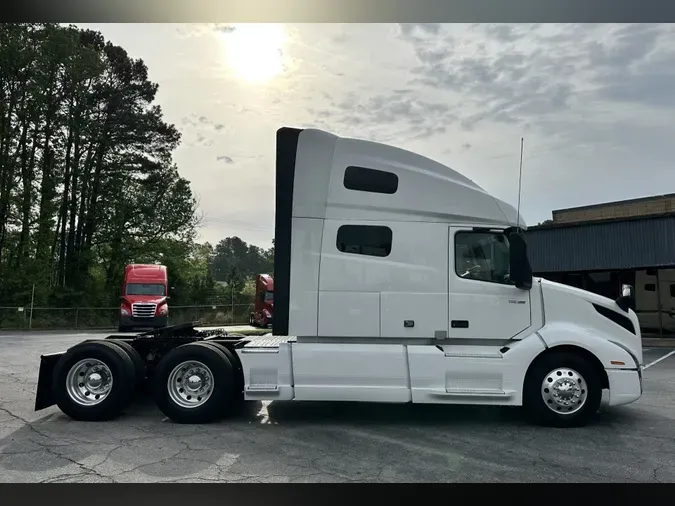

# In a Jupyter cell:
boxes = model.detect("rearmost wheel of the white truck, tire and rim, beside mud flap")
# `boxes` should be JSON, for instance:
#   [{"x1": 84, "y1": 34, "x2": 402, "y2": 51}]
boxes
[{"x1": 52, "y1": 341, "x2": 136, "y2": 421}]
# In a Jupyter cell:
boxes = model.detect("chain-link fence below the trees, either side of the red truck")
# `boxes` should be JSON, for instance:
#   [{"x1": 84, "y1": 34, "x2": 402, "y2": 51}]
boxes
[{"x1": 0, "y1": 304, "x2": 253, "y2": 330}]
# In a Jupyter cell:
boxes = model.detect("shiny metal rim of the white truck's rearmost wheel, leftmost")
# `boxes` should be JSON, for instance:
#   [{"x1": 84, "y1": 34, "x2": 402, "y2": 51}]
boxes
[{"x1": 66, "y1": 358, "x2": 113, "y2": 406}]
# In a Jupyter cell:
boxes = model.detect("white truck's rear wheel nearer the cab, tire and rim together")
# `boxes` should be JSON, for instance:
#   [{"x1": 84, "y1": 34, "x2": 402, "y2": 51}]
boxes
[{"x1": 154, "y1": 343, "x2": 234, "y2": 423}]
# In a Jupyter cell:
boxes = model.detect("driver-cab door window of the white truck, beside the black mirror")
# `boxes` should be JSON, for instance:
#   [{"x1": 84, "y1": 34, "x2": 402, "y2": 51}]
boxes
[{"x1": 455, "y1": 232, "x2": 511, "y2": 284}]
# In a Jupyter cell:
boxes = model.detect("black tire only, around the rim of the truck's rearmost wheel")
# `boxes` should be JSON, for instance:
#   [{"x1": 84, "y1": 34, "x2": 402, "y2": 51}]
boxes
[{"x1": 52, "y1": 341, "x2": 136, "y2": 422}]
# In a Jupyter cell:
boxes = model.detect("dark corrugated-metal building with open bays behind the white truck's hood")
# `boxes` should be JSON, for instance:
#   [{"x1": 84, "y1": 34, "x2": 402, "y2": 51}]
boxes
[{"x1": 526, "y1": 210, "x2": 675, "y2": 337}]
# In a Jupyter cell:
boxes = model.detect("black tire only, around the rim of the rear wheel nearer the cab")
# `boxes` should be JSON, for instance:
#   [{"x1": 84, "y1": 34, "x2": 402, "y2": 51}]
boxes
[{"x1": 153, "y1": 342, "x2": 234, "y2": 424}]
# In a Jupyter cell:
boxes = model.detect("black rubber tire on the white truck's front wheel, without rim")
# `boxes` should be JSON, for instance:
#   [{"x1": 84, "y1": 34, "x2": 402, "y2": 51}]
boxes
[{"x1": 523, "y1": 352, "x2": 602, "y2": 427}]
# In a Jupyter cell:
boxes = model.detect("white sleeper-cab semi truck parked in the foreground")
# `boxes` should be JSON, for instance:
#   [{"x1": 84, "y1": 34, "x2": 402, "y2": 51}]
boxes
[{"x1": 35, "y1": 128, "x2": 642, "y2": 426}]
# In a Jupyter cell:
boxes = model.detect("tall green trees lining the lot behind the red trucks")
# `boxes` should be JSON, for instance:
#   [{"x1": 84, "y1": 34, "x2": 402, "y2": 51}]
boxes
[{"x1": 0, "y1": 23, "x2": 274, "y2": 324}]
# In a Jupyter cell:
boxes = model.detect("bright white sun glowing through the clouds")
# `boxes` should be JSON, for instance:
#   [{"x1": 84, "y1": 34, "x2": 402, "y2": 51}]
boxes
[{"x1": 224, "y1": 23, "x2": 286, "y2": 83}]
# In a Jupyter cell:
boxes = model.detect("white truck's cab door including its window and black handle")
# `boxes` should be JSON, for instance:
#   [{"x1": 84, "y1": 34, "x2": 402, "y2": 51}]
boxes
[{"x1": 448, "y1": 227, "x2": 531, "y2": 339}]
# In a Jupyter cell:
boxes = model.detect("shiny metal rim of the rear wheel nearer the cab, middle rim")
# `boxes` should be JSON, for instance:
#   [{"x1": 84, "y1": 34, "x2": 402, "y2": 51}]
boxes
[{"x1": 166, "y1": 360, "x2": 213, "y2": 409}]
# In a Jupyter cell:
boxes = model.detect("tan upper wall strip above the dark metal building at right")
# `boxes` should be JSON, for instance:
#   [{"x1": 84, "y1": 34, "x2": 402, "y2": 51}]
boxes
[{"x1": 552, "y1": 194, "x2": 675, "y2": 224}]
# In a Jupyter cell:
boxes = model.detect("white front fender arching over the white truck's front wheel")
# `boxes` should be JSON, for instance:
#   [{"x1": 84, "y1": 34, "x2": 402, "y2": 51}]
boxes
[{"x1": 537, "y1": 323, "x2": 640, "y2": 370}]
